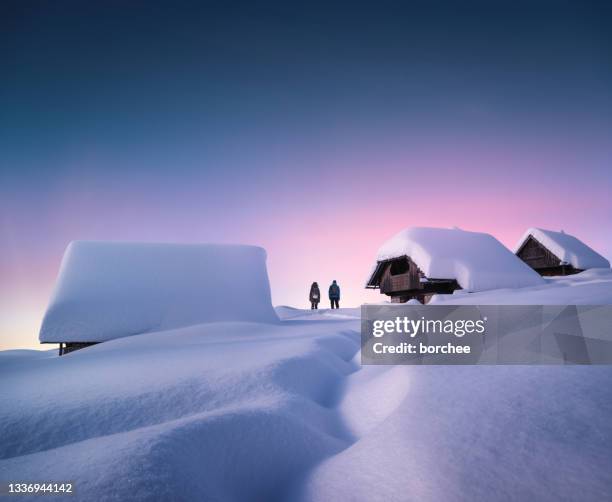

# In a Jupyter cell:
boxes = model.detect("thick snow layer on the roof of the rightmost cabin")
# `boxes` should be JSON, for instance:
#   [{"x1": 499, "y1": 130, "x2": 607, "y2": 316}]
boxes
[{"x1": 514, "y1": 228, "x2": 610, "y2": 270}]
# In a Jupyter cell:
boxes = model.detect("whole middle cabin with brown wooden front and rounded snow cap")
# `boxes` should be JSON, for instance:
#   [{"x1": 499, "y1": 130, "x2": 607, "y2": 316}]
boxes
[{"x1": 366, "y1": 227, "x2": 543, "y2": 303}]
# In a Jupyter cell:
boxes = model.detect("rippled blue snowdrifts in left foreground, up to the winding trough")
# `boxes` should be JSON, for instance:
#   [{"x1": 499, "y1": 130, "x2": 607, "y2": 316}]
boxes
[{"x1": 0, "y1": 318, "x2": 359, "y2": 501}]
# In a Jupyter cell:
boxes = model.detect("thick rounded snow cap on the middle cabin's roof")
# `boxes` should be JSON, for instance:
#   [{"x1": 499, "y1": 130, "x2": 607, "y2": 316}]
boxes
[{"x1": 368, "y1": 227, "x2": 544, "y2": 291}]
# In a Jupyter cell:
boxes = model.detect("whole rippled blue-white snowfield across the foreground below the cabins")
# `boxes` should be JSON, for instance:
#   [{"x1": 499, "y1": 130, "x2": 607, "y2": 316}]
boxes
[{"x1": 0, "y1": 298, "x2": 612, "y2": 502}]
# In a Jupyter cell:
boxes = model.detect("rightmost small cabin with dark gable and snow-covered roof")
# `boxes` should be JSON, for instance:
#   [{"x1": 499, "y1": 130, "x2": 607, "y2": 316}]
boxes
[{"x1": 515, "y1": 228, "x2": 610, "y2": 275}]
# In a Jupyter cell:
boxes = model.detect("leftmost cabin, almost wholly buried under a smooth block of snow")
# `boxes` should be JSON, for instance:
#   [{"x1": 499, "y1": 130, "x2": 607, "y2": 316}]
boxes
[{"x1": 39, "y1": 241, "x2": 278, "y2": 355}]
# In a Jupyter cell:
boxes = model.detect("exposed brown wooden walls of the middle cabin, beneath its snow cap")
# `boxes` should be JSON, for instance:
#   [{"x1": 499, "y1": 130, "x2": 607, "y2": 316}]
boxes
[{"x1": 366, "y1": 256, "x2": 461, "y2": 303}]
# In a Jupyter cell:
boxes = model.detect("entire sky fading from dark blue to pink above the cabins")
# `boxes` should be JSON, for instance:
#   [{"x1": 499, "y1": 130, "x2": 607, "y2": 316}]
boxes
[{"x1": 0, "y1": 0, "x2": 612, "y2": 348}]
